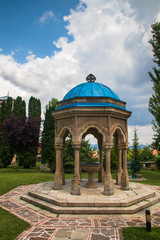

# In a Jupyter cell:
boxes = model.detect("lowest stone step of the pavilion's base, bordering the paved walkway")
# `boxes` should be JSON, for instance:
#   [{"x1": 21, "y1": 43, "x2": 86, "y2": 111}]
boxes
[{"x1": 21, "y1": 193, "x2": 160, "y2": 214}]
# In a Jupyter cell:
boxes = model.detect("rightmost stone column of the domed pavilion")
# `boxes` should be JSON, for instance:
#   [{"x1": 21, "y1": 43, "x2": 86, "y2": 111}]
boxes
[{"x1": 121, "y1": 148, "x2": 129, "y2": 190}]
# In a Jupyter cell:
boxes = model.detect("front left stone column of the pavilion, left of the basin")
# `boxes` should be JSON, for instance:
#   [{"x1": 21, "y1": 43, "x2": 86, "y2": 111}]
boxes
[{"x1": 71, "y1": 144, "x2": 81, "y2": 195}]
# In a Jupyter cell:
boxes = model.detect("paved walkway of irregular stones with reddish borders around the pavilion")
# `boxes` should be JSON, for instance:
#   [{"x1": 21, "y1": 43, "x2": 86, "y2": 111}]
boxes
[{"x1": 0, "y1": 186, "x2": 160, "y2": 240}]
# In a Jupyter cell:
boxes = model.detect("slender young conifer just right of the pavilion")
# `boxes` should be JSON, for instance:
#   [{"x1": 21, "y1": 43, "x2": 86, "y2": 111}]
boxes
[{"x1": 131, "y1": 128, "x2": 141, "y2": 173}]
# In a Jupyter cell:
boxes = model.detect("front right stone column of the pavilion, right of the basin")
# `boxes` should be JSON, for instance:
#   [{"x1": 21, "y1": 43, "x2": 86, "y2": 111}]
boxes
[{"x1": 104, "y1": 146, "x2": 114, "y2": 196}]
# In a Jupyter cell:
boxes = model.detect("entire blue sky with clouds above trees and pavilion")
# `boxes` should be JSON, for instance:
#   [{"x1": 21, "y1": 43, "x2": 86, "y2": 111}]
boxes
[{"x1": 0, "y1": 0, "x2": 160, "y2": 144}]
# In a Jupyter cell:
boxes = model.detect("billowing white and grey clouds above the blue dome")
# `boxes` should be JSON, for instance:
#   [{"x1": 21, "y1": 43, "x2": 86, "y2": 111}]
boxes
[{"x1": 0, "y1": 0, "x2": 158, "y2": 141}]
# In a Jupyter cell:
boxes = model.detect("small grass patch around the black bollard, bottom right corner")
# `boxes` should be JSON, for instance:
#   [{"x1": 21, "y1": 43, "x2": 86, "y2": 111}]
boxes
[{"x1": 122, "y1": 227, "x2": 160, "y2": 240}]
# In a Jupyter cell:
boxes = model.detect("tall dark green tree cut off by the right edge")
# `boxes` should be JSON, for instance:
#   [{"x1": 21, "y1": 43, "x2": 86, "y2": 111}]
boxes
[{"x1": 149, "y1": 22, "x2": 160, "y2": 150}]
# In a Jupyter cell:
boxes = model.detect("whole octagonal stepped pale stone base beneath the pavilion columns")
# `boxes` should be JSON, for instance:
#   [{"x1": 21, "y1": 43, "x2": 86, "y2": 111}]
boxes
[{"x1": 21, "y1": 180, "x2": 160, "y2": 214}]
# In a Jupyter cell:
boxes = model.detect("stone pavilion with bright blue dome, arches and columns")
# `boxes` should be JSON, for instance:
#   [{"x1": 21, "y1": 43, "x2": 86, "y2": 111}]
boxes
[{"x1": 53, "y1": 74, "x2": 131, "y2": 195}]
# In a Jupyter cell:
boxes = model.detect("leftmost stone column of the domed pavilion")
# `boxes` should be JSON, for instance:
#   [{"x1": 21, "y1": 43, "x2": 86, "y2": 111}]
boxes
[{"x1": 53, "y1": 146, "x2": 63, "y2": 190}]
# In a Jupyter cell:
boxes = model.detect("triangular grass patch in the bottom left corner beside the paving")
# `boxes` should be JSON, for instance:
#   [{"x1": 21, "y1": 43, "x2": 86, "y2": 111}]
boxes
[{"x1": 0, "y1": 208, "x2": 30, "y2": 240}]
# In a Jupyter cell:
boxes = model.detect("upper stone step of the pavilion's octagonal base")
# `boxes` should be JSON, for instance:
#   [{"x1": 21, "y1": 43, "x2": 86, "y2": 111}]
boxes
[{"x1": 28, "y1": 191, "x2": 155, "y2": 207}]
